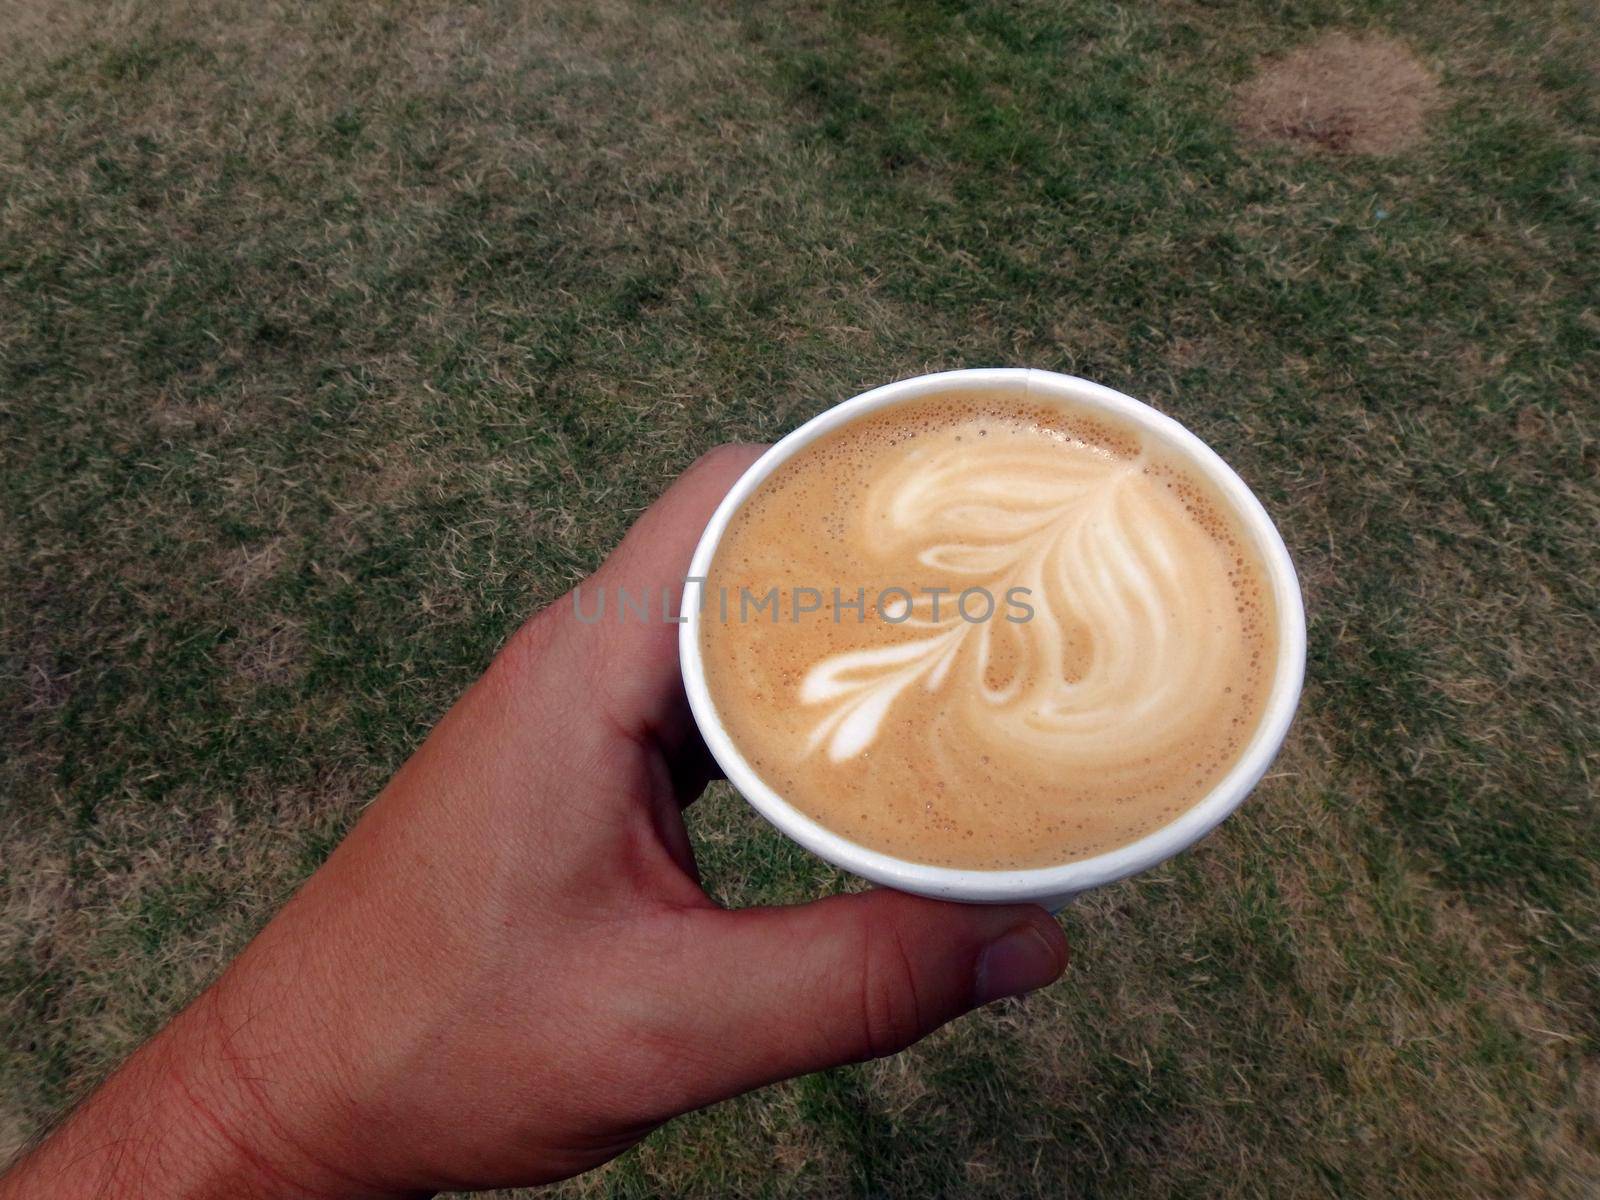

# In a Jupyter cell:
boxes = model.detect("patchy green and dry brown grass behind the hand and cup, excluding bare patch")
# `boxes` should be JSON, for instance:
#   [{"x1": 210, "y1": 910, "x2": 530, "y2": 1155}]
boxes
[{"x1": 0, "y1": 0, "x2": 1600, "y2": 1197}]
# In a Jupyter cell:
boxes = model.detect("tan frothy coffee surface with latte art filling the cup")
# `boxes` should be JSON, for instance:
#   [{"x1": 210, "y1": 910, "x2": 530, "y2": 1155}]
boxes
[{"x1": 701, "y1": 394, "x2": 1275, "y2": 867}]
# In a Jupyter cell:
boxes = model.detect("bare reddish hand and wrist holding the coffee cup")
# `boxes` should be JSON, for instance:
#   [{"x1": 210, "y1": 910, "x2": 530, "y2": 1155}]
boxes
[{"x1": 0, "y1": 446, "x2": 1067, "y2": 1198}]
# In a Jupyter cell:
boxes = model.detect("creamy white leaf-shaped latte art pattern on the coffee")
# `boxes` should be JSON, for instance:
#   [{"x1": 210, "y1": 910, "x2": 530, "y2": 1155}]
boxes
[{"x1": 798, "y1": 435, "x2": 1237, "y2": 768}]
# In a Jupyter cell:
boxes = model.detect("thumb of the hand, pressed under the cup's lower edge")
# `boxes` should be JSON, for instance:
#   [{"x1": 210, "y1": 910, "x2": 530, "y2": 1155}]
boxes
[{"x1": 662, "y1": 890, "x2": 1067, "y2": 1102}]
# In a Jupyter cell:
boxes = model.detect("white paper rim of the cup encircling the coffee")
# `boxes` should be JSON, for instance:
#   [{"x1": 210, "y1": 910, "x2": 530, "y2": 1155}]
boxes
[{"x1": 678, "y1": 368, "x2": 1306, "y2": 909}]
